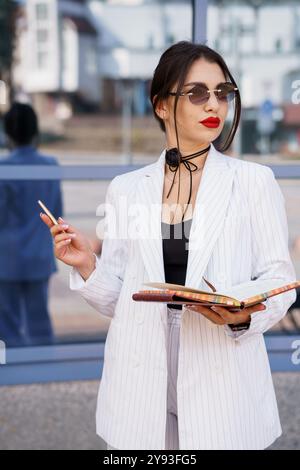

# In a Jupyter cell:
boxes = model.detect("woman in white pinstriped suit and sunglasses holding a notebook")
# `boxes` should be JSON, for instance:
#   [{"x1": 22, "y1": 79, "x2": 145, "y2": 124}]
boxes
[{"x1": 41, "y1": 42, "x2": 295, "y2": 450}]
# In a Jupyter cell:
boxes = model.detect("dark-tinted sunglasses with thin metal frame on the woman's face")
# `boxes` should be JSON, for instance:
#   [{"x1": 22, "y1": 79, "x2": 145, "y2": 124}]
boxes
[{"x1": 169, "y1": 82, "x2": 238, "y2": 104}]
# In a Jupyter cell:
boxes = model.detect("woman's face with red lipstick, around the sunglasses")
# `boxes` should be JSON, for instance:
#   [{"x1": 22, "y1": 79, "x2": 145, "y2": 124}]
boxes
[{"x1": 159, "y1": 59, "x2": 228, "y2": 149}]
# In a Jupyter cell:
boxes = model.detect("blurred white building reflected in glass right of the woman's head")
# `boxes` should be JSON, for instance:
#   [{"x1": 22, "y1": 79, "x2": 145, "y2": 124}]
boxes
[{"x1": 207, "y1": 0, "x2": 300, "y2": 153}]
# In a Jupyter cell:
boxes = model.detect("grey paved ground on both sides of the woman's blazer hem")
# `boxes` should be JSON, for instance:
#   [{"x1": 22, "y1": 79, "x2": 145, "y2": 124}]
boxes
[{"x1": 0, "y1": 373, "x2": 300, "y2": 450}]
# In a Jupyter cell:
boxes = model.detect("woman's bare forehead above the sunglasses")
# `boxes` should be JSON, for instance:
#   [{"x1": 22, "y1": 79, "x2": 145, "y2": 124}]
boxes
[{"x1": 184, "y1": 59, "x2": 226, "y2": 87}]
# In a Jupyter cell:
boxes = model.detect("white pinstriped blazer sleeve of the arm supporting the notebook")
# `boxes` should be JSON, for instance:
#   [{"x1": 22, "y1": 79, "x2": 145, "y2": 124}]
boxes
[{"x1": 225, "y1": 165, "x2": 296, "y2": 341}]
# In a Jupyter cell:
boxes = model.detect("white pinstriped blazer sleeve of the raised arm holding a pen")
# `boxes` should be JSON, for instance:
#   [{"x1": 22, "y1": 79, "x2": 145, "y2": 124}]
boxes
[{"x1": 69, "y1": 178, "x2": 128, "y2": 318}]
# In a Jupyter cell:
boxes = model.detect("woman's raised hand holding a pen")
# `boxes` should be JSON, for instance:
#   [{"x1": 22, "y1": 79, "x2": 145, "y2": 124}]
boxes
[{"x1": 40, "y1": 213, "x2": 95, "y2": 279}]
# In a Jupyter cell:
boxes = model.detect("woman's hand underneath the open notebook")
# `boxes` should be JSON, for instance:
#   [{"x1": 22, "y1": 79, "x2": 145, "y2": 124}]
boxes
[{"x1": 185, "y1": 303, "x2": 266, "y2": 325}]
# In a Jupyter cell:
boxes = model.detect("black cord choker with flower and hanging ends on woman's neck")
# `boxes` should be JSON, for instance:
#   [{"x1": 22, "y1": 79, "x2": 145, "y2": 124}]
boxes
[{"x1": 165, "y1": 145, "x2": 211, "y2": 221}]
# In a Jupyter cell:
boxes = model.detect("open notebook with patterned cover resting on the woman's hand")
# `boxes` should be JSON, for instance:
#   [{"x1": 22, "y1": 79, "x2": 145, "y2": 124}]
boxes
[{"x1": 132, "y1": 279, "x2": 300, "y2": 311}]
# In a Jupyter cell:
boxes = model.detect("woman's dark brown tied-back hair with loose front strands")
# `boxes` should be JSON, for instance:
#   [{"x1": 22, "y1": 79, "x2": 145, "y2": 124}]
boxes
[{"x1": 150, "y1": 41, "x2": 241, "y2": 152}]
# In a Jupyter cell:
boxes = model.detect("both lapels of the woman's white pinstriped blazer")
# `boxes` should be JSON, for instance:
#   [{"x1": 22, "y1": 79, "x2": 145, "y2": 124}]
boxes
[{"x1": 136, "y1": 145, "x2": 235, "y2": 288}]
